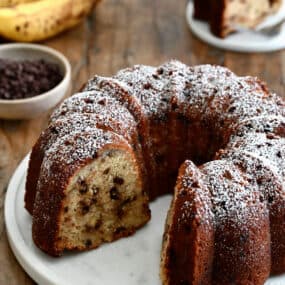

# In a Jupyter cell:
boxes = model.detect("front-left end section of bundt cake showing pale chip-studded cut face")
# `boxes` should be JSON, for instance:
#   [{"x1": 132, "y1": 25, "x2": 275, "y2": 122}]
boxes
[{"x1": 32, "y1": 129, "x2": 150, "y2": 256}]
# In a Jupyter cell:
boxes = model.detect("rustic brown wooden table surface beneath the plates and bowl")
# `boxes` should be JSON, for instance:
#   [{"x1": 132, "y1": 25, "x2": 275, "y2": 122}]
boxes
[{"x1": 0, "y1": 0, "x2": 285, "y2": 285}]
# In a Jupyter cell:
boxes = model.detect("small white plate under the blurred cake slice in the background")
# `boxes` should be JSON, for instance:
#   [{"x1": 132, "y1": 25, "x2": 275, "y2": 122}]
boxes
[{"x1": 186, "y1": 1, "x2": 285, "y2": 52}]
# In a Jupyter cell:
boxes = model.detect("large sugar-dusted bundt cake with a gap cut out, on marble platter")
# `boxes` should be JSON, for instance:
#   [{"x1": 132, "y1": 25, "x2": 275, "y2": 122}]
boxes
[{"x1": 25, "y1": 61, "x2": 285, "y2": 285}]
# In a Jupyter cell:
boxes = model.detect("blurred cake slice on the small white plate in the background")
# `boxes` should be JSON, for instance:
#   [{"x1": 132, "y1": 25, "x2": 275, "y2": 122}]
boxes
[{"x1": 194, "y1": 0, "x2": 282, "y2": 38}]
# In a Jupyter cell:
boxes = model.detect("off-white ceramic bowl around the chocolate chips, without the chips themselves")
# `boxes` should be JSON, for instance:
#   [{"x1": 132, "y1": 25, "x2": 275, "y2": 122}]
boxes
[{"x1": 0, "y1": 44, "x2": 71, "y2": 119}]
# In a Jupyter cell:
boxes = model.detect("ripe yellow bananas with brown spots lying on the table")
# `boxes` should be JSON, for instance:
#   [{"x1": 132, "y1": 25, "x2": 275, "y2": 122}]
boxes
[{"x1": 0, "y1": 0, "x2": 99, "y2": 42}]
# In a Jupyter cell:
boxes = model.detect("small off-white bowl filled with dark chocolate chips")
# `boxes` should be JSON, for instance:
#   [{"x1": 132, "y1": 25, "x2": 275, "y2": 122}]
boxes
[{"x1": 0, "y1": 44, "x2": 71, "y2": 119}]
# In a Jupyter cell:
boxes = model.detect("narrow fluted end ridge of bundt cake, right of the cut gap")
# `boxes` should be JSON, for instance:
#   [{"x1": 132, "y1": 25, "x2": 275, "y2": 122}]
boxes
[{"x1": 160, "y1": 160, "x2": 214, "y2": 285}]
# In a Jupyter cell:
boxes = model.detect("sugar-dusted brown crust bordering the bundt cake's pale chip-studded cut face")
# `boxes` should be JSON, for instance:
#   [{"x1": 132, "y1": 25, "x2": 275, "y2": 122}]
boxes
[{"x1": 32, "y1": 129, "x2": 149, "y2": 256}]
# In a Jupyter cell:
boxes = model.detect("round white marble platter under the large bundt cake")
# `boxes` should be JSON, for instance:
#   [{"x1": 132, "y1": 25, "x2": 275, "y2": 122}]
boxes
[{"x1": 5, "y1": 156, "x2": 285, "y2": 285}]
